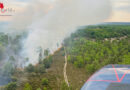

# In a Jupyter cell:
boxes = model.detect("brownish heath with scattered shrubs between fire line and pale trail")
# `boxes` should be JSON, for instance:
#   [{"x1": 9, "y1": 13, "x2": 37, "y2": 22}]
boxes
[{"x1": 14, "y1": 49, "x2": 64, "y2": 90}]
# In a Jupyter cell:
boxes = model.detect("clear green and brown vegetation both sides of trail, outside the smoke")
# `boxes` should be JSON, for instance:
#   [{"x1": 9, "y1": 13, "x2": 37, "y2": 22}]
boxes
[{"x1": 17, "y1": 25, "x2": 130, "y2": 90}]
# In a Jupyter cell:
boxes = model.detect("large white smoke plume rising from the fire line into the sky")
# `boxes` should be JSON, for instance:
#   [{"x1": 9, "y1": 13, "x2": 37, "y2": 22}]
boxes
[{"x1": 12, "y1": 0, "x2": 111, "y2": 64}]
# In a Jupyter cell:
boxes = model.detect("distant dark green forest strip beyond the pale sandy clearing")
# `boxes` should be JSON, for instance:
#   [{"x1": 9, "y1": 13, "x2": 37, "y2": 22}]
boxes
[{"x1": 71, "y1": 25, "x2": 130, "y2": 40}]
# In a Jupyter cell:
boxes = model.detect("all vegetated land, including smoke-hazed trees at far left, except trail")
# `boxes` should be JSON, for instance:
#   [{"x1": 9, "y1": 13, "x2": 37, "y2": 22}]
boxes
[{"x1": 0, "y1": 25, "x2": 130, "y2": 90}]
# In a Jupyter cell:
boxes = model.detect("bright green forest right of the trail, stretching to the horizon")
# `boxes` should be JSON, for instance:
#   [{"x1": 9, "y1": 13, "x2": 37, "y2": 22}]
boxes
[{"x1": 65, "y1": 25, "x2": 130, "y2": 74}]
